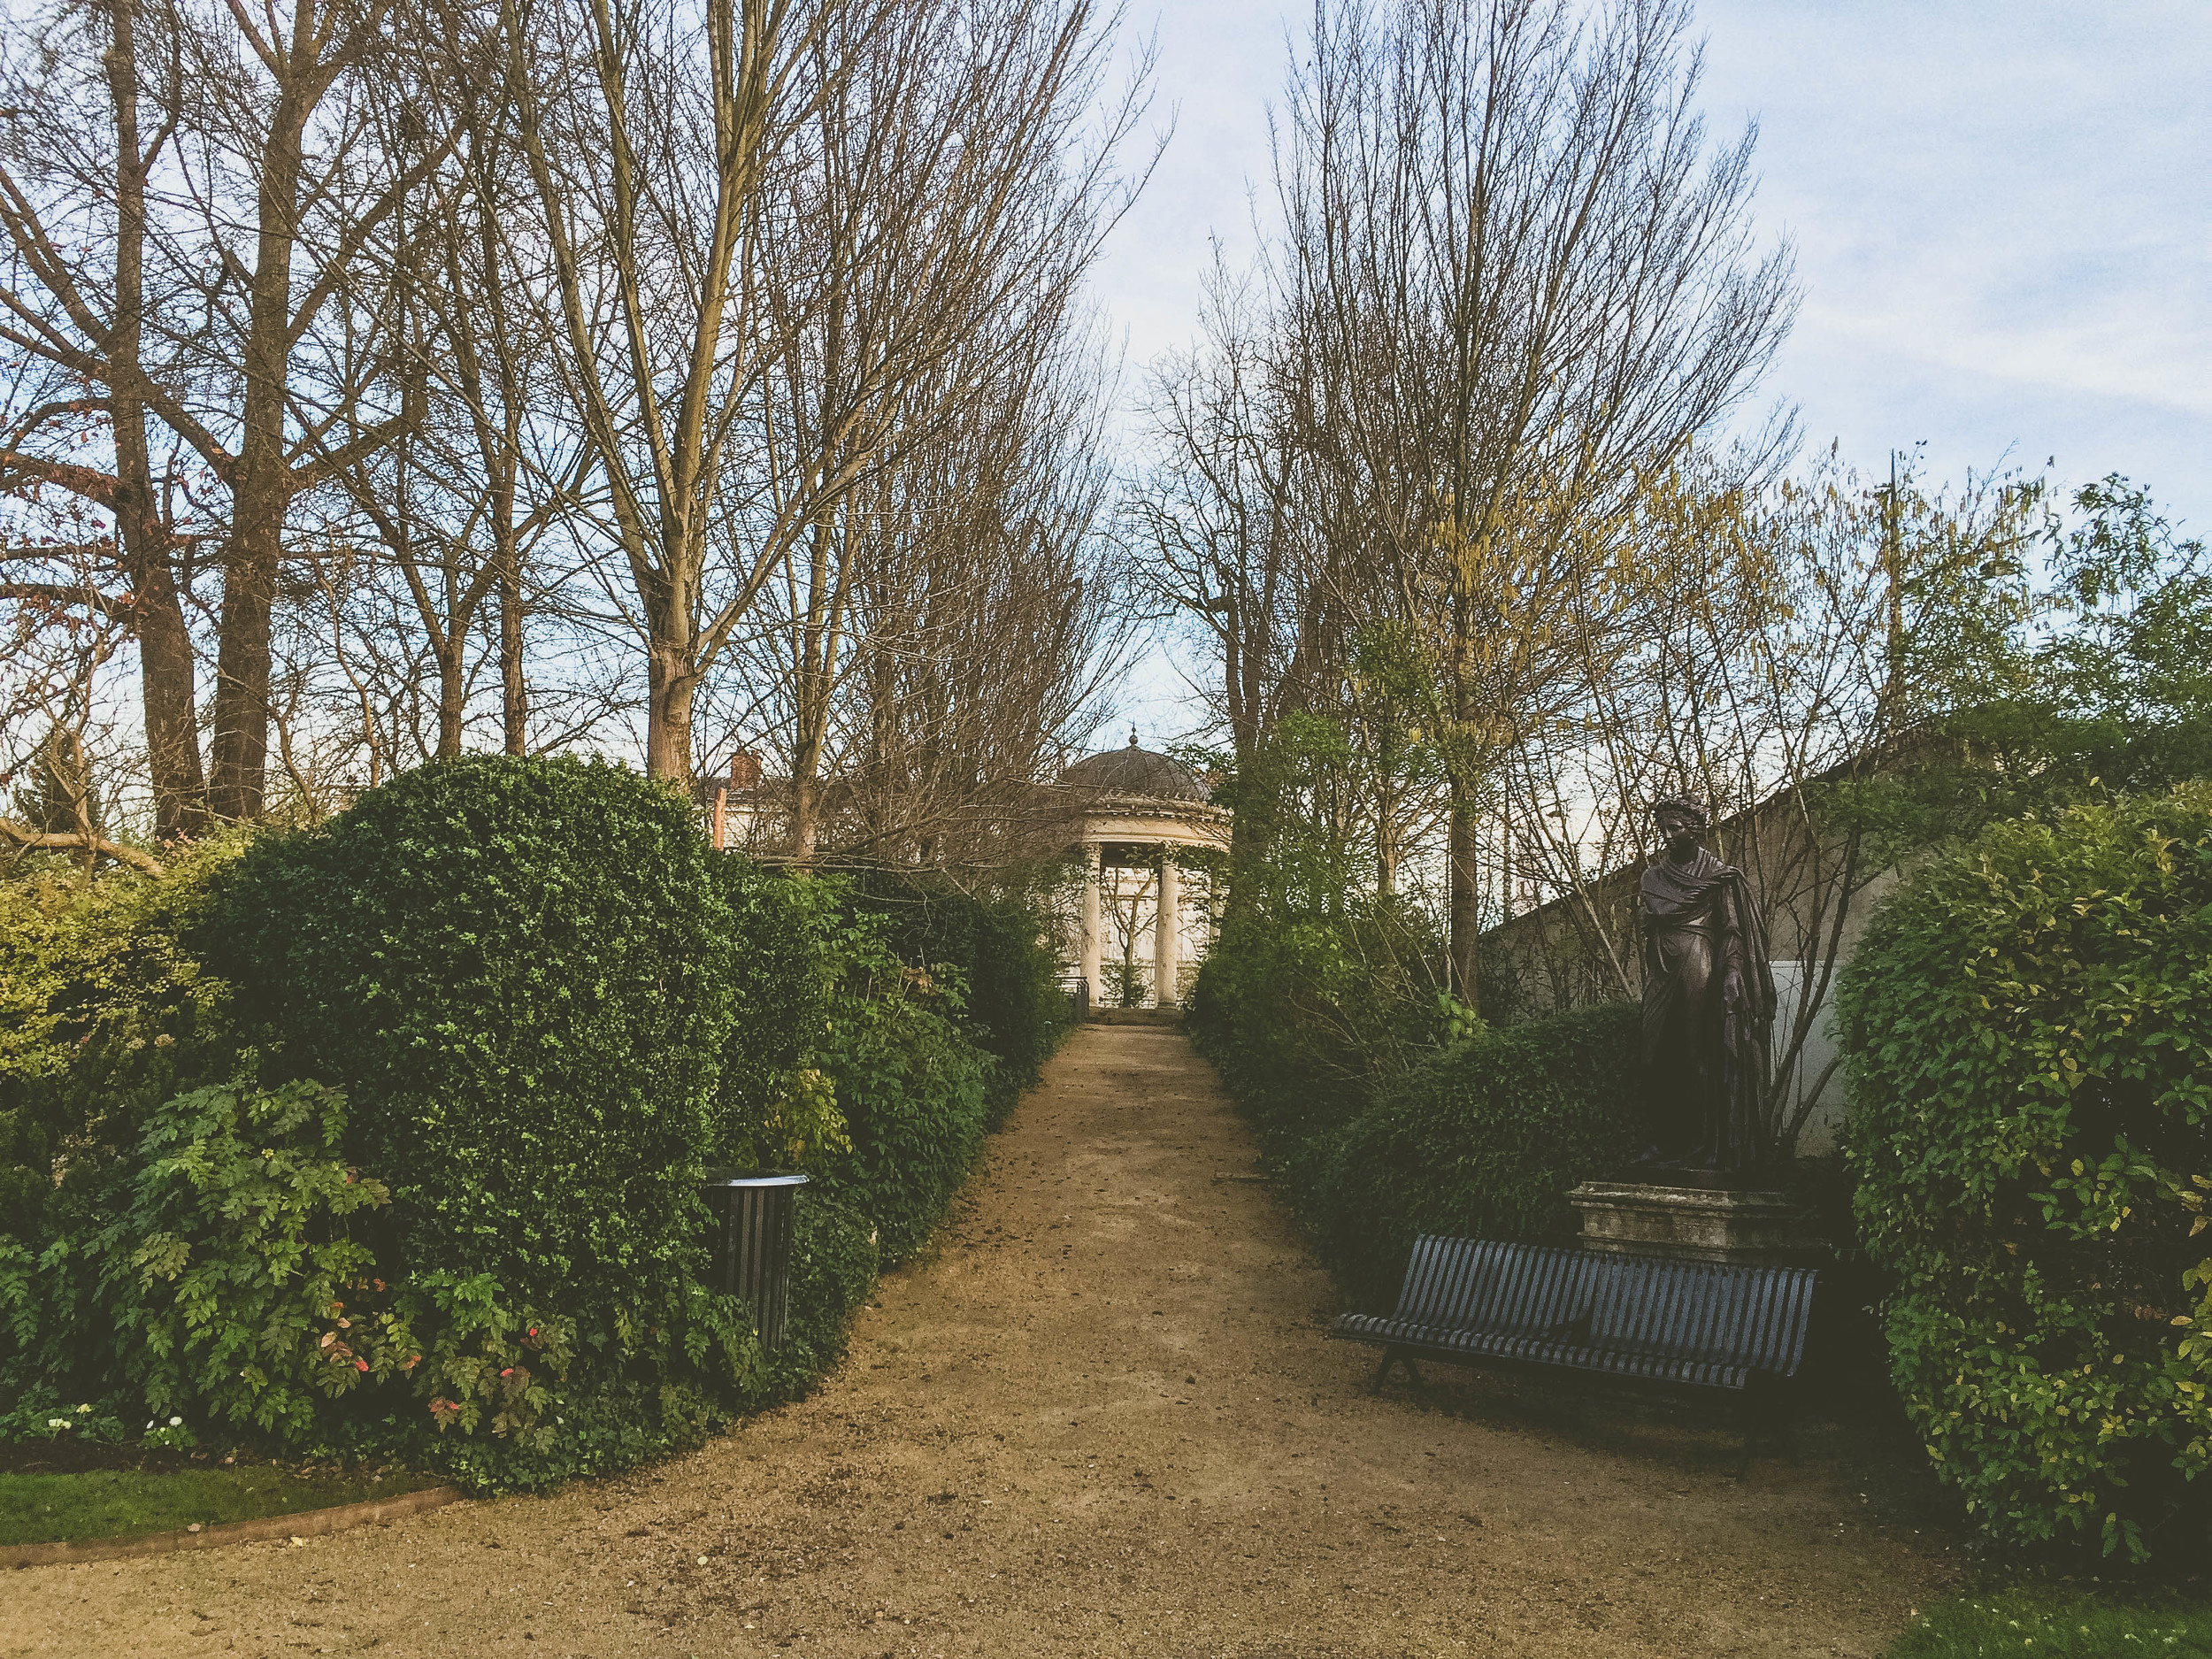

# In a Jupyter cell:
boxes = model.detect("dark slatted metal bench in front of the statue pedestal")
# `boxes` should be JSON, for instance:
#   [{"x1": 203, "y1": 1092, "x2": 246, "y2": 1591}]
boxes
[{"x1": 1330, "y1": 1237, "x2": 1818, "y2": 1476}]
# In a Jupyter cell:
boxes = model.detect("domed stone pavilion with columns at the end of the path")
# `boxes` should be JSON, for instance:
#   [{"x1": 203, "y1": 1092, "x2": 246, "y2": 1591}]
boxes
[{"x1": 1060, "y1": 728, "x2": 1233, "y2": 1009}]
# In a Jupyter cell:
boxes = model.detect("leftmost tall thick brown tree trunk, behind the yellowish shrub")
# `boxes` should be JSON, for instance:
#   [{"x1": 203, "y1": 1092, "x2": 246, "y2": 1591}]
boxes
[{"x1": 106, "y1": 0, "x2": 208, "y2": 841}]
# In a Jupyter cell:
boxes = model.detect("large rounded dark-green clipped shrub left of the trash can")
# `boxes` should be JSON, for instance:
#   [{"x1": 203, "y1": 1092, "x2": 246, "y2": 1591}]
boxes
[{"x1": 224, "y1": 757, "x2": 734, "y2": 1318}]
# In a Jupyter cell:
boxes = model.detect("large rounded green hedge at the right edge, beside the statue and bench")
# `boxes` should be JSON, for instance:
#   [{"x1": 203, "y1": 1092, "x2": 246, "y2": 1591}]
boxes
[{"x1": 1840, "y1": 783, "x2": 2212, "y2": 1555}]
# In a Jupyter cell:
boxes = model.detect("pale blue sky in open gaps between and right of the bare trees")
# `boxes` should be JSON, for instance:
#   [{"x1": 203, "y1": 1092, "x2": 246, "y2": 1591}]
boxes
[{"x1": 1095, "y1": 0, "x2": 2212, "y2": 748}]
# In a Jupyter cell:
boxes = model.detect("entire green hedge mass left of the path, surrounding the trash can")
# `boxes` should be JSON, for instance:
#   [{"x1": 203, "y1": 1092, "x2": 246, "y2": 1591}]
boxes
[{"x1": 0, "y1": 757, "x2": 1071, "y2": 1489}]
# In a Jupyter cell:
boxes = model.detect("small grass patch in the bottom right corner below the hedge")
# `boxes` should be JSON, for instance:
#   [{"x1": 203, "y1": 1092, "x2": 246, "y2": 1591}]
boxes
[{"x1": 1885, "y1": 1591, "x2": 2212, "y2": 1659}]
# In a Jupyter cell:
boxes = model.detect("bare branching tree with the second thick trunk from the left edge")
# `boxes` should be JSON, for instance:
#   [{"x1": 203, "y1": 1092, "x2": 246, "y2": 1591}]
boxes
[{"x1": 0, "y1": 0, "x2": 451, "y2": 818}]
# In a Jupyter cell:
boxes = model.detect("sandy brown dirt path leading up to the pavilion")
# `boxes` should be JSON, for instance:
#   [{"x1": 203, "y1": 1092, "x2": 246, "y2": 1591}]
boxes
[{"x1": 0, "y1": 1026, "x2": 1958, "y2": 1659}]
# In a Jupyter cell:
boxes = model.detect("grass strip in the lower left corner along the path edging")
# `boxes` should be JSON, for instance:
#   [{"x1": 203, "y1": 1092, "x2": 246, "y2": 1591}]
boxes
[{"x1": 0, "y1": 1464, "x2": 436, "y2": 1544}]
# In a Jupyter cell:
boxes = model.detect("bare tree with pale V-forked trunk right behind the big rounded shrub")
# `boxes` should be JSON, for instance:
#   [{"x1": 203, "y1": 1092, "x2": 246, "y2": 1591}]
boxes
[{"x1": 500, "y1": 0, "x2": 858, "y2": 779}]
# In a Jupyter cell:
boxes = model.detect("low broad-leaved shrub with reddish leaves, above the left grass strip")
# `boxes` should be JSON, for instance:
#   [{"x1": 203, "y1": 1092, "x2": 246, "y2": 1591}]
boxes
[{"x1": 0, "y1": 1082, "x2": 611, "y2": 1485}]
